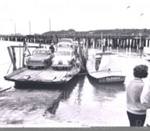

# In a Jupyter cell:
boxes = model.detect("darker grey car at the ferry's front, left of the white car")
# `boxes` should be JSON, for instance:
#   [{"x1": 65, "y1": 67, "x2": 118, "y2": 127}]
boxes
[{"x1": 26, "y1": 48, "x2": 54, "y2": 69}]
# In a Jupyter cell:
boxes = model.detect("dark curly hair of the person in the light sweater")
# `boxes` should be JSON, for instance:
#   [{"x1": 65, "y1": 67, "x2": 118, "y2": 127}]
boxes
[{"x1": 133, "y1": 65, "x2": 148, "y2": 78}]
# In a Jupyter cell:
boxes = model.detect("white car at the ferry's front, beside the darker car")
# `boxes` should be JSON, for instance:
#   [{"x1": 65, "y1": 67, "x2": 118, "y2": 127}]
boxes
[{"x1": 51, "y1": 48, "x2": 76, "y2": 69}]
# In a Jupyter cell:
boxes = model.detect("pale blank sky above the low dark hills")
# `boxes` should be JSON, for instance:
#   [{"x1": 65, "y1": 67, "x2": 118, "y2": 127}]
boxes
[{"x1": 0, "y1": 0, "x2": 150, "y2": 35}]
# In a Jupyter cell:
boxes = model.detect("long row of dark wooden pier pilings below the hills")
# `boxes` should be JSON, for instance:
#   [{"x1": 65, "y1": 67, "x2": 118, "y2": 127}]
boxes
[{"x1": 0, "y1": 35, "x2": 150, "y2": 49}]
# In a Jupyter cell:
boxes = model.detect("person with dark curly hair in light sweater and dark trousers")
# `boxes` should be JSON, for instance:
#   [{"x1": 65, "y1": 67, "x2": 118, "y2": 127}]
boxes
[{"x1": 125, "y1": 65, "x2": 148, "y2": 126}]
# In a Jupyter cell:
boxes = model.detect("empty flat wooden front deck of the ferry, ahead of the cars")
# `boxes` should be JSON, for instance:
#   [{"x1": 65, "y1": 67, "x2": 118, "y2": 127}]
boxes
[{"x1": 4, "y1": 67, "x2": 79, "y2": 83}]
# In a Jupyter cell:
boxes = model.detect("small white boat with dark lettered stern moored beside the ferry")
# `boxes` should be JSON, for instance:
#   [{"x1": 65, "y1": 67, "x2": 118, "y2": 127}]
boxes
[{"x1": 86, "y1": 51, "x2": 125, "y2": 83}]
